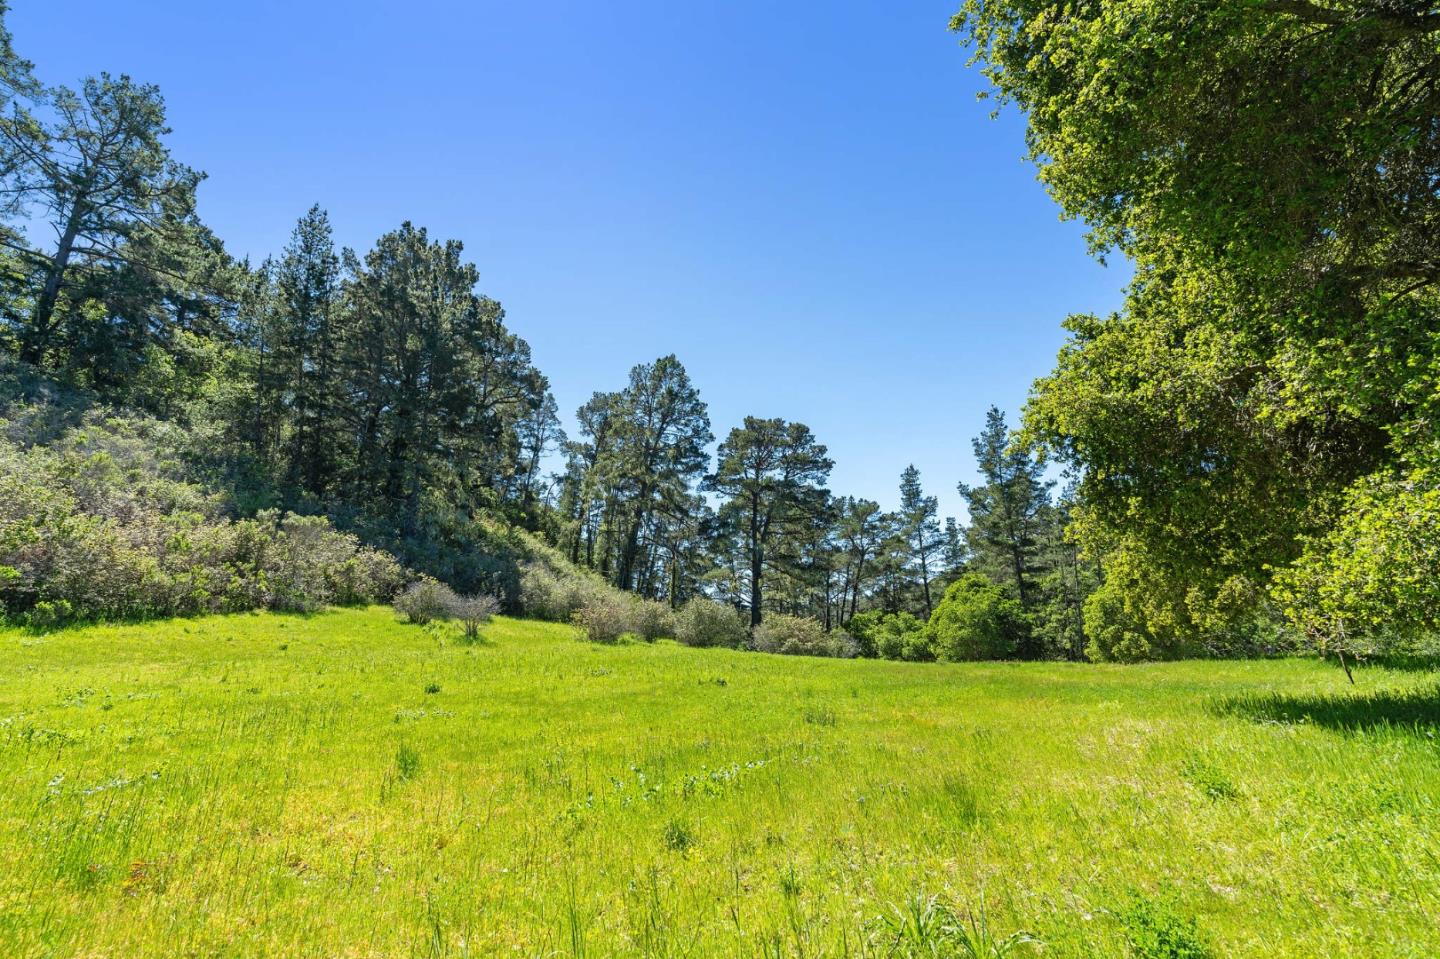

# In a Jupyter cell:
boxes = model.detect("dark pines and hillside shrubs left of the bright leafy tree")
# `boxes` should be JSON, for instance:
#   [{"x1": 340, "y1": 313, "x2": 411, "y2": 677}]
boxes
[{"x1": 0, "y1": 0, "x2": 1094, "y2": 658}]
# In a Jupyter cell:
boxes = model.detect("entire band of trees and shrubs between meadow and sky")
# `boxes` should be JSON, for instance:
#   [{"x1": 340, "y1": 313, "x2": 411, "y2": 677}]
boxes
[{"x1": 0, "y1": 0, "x2": 1440, "y2": 659}]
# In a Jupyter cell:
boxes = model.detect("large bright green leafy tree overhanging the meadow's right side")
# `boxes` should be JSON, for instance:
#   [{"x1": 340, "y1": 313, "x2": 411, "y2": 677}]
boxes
[{"x1": 953, "y1": 0, "x2": 1440, "y2": 651}]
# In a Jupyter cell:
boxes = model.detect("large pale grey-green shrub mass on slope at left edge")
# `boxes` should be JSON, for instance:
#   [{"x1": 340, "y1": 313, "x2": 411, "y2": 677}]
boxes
[{"x1": 0, "y1": 416, "x2": 406, "y2": 626}]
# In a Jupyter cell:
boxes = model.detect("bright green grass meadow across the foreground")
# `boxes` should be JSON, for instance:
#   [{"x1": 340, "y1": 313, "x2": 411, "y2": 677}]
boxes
[{"x1": 0, "y1": 609, "x2": 1440, "y2": 959}]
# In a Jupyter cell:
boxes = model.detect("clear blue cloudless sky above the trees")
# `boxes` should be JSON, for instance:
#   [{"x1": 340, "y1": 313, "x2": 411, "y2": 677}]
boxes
[{"x1": 9, "y1": 0, "x2": 1129, "y2": 515}]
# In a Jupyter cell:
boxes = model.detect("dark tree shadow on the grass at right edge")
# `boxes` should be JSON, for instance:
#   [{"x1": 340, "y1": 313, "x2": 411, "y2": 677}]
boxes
[{"x1": 1212, "y1": 687, "x2": 1440, "y2": 731}]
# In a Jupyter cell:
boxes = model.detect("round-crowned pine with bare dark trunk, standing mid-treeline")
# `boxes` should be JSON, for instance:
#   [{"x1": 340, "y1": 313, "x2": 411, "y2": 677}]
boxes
[{"x1": 704, "y1": 416, "x2": 834, "y2": 628}]
